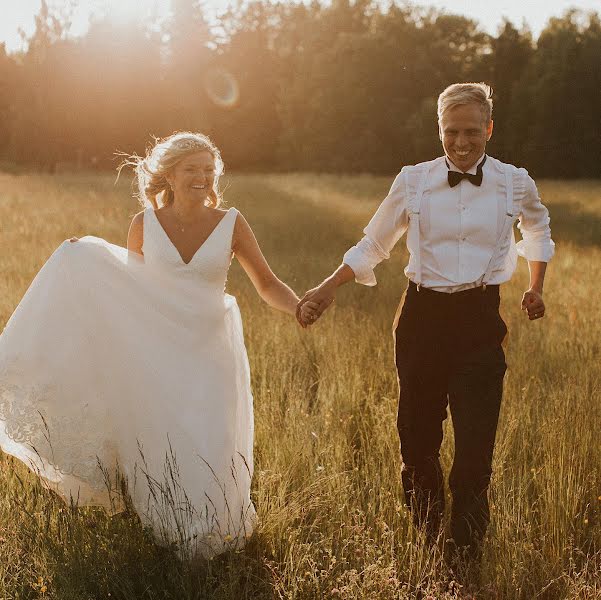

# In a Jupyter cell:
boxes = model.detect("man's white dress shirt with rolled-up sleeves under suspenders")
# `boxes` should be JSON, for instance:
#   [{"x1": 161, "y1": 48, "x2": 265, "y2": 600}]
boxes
[{"x1": 343, "y1": 155, "x2": 555, "y2": 293}]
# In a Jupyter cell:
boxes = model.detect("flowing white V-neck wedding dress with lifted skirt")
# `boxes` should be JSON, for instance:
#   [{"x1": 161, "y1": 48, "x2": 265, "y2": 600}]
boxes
[{"x1": 0, "y1": 208, "x2": 255, "y2": 555}]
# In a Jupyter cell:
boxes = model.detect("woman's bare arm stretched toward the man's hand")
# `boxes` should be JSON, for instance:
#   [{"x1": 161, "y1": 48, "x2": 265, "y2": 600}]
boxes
[{"x1": 232, "y1": 213, "x2": 298, "y2": 315}]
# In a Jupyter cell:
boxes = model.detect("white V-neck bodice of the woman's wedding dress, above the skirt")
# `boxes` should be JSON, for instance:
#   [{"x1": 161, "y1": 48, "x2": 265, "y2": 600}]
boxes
[{"x1": 142, "y1": 208, "x2": 238, "y2": 289}]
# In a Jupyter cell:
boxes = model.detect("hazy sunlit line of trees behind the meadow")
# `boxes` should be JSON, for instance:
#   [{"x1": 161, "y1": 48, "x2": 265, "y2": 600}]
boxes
[{"x1": 0, "y1": 0, "x2": 601, "y2": 177}]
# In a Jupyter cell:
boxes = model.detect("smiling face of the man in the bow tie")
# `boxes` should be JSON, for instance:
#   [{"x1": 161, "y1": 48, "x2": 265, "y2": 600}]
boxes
[{"x1": 438, "y1": 104, "x2": 493, "y2": 171}]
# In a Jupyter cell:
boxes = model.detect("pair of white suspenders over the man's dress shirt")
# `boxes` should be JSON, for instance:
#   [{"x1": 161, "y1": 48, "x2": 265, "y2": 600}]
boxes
[{"x1": 405, "y1": 163, "x2": 514, "y2": 290}]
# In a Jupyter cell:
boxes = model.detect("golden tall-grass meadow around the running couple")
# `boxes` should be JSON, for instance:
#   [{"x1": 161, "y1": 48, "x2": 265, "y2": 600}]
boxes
[{"x1": 0, "y1": 174, "x2": 601, "y2": 600}]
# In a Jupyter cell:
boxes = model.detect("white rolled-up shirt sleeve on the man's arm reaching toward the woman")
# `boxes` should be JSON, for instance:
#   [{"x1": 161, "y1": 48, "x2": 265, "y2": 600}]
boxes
[{"x1": 342, "y1": 171, "x2": 408, "y2": 286}]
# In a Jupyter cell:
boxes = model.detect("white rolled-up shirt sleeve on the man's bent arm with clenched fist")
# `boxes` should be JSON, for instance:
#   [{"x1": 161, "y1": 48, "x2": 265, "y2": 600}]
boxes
[{"x1": 516, "y1": 173, "x2": 555, "y2": 262}]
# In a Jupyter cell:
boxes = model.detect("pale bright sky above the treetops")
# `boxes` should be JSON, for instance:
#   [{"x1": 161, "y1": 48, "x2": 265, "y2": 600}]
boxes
[{"x1": 0, "y1": 0, "x2": 601, "y2": 52}]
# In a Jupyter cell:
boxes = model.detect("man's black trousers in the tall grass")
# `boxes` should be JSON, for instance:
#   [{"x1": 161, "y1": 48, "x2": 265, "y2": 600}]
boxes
[{"x1": 395, "y1": 282, "x2": 507, "y2": 552}]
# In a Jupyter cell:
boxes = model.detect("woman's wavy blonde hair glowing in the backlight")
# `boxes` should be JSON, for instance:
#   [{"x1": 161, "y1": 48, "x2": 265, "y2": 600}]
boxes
[{"x1": 121, "y1": 131, "x2": 223, "y2": 209}]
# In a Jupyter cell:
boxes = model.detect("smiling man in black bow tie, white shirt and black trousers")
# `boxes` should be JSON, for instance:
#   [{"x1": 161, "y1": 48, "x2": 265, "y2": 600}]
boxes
[{"x1": 297, "y1": 83, "x2": 554, "y2": 558}]
